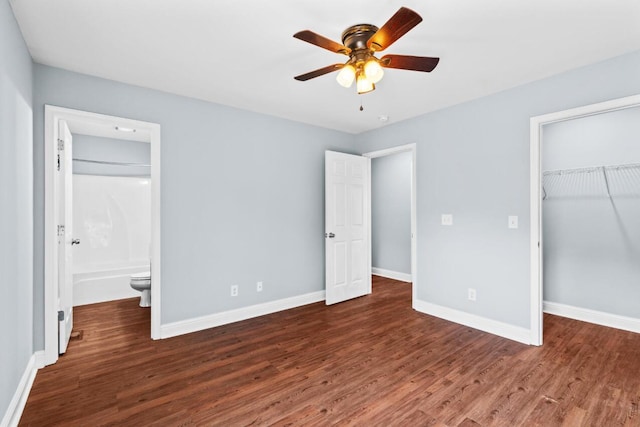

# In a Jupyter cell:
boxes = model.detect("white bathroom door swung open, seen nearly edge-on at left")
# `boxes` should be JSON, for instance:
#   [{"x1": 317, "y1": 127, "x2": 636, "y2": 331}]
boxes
[{"x1": 56, "y1": 120, "x2": 73, "y2": 354}]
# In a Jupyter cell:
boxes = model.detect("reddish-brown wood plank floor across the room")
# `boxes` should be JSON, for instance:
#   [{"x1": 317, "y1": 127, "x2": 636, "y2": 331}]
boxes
[{"x1": 20, "y1": 277, "x2": 640, "y2": 427}]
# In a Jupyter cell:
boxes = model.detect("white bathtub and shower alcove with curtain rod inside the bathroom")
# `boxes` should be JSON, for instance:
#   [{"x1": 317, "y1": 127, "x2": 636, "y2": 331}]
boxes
[{"x1": 71, "y1": 135, "x2": 151, "y2": 307}]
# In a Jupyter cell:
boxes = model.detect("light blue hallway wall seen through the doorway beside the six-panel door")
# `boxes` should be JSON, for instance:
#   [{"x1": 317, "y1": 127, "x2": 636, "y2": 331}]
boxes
[{"x1": 371, "y1": 152, "x2": 412, "y2": 274}]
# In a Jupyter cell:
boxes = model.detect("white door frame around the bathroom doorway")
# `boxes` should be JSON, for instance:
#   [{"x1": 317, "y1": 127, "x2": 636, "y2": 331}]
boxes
[{"x1": 44, "y1": 105, "x2": 161, "y2": 365}]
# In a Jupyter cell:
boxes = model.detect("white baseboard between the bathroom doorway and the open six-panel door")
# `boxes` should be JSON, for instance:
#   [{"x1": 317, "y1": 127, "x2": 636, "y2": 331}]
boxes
[{"x1": 160, "y1": 291, "x2": 325, "y2": 338}]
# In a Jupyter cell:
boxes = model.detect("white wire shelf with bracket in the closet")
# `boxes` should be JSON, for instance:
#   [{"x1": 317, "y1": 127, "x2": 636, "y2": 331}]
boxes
[{"x1": 542, "y1": 163, "x2": 640, "y2": 200}]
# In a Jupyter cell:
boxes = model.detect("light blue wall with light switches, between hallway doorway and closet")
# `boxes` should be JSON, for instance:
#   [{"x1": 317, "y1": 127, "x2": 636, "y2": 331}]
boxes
[{"x1": 356, "y1": 51, "x2": 640, "y2": 328}]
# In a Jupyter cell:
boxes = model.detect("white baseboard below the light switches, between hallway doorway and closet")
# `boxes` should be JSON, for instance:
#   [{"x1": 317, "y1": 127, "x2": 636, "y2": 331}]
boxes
[{"x1": 413, "y1": 299, "x2": 531, "y2": 344}]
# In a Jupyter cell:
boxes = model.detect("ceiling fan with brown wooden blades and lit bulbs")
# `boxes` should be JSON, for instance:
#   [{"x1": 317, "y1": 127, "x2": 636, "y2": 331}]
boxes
[{"x1": 293, "y1": 7, "x2": 440, "y2": 94}]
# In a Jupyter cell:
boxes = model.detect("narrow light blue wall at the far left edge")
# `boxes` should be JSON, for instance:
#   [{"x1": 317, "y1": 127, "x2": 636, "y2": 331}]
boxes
[{"x1": 0, "y1": 0, "x2": 33, "y2": 419}]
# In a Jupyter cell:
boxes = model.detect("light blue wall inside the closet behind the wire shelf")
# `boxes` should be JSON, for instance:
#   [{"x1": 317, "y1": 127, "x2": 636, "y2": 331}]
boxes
[{"x1": 542, "y1": 107, "x2": 640, "y2": 318}]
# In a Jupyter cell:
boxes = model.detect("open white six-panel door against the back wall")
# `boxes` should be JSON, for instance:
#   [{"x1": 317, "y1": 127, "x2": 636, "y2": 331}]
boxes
[{"x1": 325, "y1": 151, "x2": 371, "y2": 305}]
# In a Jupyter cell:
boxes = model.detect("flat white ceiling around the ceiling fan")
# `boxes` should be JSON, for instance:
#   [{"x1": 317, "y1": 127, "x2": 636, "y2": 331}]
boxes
[{"x1": 10, "y1": 0, "x2": 640, "y2": 133}]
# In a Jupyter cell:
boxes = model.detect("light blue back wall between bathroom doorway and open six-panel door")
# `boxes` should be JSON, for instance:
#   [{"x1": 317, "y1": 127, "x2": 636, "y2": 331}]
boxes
[{"x1": 34, "y1": 65, "x2": 354, "y2": 349}]
